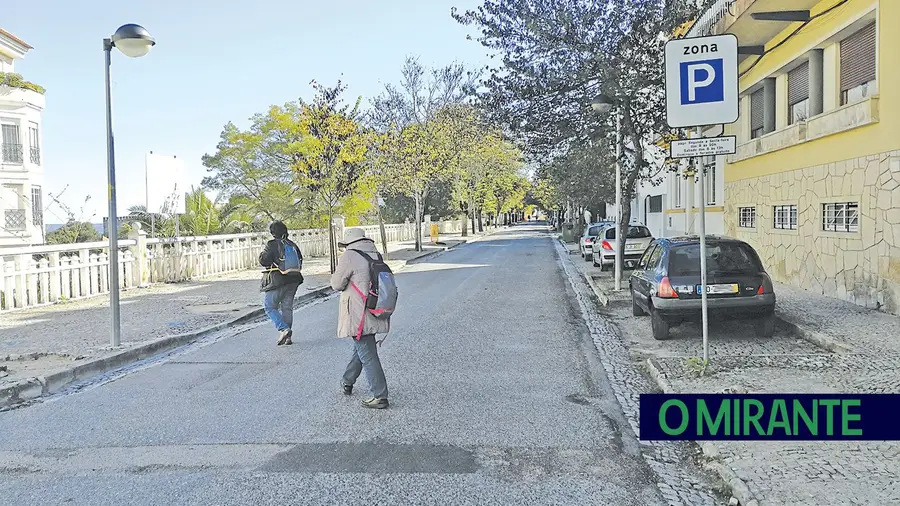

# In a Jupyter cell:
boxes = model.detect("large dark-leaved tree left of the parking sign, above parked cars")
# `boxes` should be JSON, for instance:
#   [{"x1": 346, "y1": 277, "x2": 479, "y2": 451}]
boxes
[{"x1": 453, "y1": 0, "x2": 712, "y2": 274}]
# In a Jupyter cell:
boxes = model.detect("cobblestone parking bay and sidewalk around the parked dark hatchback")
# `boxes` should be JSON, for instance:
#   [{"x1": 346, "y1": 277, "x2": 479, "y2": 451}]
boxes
[{"x1": 571, "y1": 239, "x2": 900, "y2": 506}]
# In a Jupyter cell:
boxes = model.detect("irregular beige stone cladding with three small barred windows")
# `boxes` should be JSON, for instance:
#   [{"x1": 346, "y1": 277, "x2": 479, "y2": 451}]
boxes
[{"x1": 725, "y1": 150, "x2": 900, "y2": 315}]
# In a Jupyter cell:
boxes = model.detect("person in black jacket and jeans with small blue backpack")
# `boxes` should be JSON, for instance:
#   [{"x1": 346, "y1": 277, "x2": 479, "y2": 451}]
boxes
[{"x1": 259, "y1": 221, "x2": 303, "y2": 346}]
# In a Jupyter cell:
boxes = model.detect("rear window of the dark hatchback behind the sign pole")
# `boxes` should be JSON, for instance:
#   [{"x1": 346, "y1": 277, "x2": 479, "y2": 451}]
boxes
[{"x1": 669, "y1": 243, "x2": 762, "y2": 277}]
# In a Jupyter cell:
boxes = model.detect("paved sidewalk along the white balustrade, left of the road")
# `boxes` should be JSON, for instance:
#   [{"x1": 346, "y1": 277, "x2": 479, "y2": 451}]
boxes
[{"x1": 0, "y1": 234, "x2": 472, "y2": 387}]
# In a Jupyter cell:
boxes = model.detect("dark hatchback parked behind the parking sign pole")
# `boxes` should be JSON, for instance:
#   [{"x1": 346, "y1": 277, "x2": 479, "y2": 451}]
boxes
[{"x1": 629, "y1": 236, "x2": 775, "y2": 340}]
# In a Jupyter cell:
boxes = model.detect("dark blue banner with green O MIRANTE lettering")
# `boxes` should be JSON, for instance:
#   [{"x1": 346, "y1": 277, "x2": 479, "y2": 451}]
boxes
[{"x1": 640, "y1": 394, "x2": 900, "y2": 441}]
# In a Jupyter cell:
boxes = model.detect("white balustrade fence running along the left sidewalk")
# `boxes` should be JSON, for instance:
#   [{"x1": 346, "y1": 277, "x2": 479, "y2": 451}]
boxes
[{"x1": 0, "y1": 220, "x2": 462, "y2": 312}]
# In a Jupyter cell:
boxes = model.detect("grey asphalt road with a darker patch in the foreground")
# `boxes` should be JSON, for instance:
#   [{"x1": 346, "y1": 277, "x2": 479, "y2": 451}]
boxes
[{"x1": 0, "y1": 226, "x2": 662, "y2": 506}]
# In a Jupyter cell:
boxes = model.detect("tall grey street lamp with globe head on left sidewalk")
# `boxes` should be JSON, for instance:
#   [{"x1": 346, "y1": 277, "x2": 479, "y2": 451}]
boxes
[{"x1": 103, "y1": 24, "x2": 156, "y2": 347}]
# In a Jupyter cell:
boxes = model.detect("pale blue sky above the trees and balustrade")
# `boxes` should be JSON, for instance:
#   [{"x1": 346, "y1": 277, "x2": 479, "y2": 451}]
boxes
[{"x1": 0, "y1": 0, "x2": 489, "y2": 223}]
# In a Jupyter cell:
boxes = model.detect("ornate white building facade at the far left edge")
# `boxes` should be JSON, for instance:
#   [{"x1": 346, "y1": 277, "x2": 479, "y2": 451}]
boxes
[{"x1": 0, "y1": 28, "x2": 44, "y2": 248}]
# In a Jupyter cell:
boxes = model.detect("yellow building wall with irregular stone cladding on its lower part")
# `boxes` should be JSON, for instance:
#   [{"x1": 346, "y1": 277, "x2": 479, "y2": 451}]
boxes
[{"x1": 724, "y1": 0, "x2": 900, "y2": 314}]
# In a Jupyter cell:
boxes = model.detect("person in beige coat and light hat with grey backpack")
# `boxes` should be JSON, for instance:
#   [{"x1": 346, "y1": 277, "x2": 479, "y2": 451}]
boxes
[{"x1": 331, "y1": 228, "x2": 397, "y2": 409}]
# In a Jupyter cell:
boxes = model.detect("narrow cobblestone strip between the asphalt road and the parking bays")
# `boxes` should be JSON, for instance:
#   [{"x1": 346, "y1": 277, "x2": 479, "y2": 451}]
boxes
[{"x1": 557, "y1": 239, "x2": 725, "y2": 506}]
